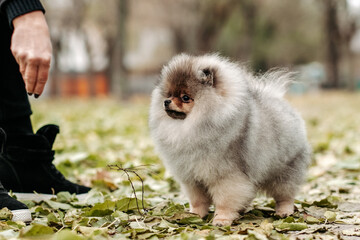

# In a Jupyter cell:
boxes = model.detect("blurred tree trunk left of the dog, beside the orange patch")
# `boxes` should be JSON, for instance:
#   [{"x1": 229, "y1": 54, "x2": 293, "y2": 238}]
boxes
[{"x1": 108, "y1": 0, "x2": 129, "y2": 98}]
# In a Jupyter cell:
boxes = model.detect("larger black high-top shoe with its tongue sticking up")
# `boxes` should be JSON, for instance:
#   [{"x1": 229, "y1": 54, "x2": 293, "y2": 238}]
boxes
[{"x1": 0, "y1": 125, "x2": 90, "y2": 197}]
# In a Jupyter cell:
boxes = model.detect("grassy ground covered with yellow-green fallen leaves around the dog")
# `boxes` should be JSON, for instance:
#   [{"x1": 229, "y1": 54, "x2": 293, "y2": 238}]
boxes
[{"x1": 0, "y1": 93, "x2": 360, "y2": 240}]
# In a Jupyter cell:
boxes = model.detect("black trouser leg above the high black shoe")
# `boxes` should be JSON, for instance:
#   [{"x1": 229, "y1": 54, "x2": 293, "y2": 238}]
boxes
[{"x1": 0, "y1": 14, "x2": 33, "y2": 134}]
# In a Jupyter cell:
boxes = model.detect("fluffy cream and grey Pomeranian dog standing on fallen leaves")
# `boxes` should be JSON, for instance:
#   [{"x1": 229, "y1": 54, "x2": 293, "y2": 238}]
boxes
[{"x1": 149, "y1": 54, "x2": 311, "y2": 226}]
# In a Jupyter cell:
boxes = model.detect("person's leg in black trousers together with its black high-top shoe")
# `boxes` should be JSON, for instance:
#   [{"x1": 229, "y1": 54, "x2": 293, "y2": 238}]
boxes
[{"x1": 0, "y1": 16, "x2": 90, "y2": 199}]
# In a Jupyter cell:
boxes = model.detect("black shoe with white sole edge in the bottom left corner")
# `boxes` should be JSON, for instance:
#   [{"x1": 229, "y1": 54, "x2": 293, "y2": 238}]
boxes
[{"x1": 0, "y1": 182, "x2": 32, "y2": 222}]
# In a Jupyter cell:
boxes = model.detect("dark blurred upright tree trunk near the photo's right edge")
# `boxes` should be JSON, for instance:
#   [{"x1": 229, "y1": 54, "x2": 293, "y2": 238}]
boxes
[{"x1": 324, "y1": 0, "x2": 341, "y2": 88}]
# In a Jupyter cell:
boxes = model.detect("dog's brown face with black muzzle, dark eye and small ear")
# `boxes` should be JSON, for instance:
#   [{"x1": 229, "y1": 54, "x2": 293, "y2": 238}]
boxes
[{"x1": 162, "y1": 60, "x2": 214, "y2": 120}]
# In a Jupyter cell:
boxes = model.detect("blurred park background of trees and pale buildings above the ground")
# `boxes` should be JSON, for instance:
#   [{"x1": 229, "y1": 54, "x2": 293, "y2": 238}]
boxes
[{"x1": 43, "y1": 0, "x2": 360, "y2": 97}]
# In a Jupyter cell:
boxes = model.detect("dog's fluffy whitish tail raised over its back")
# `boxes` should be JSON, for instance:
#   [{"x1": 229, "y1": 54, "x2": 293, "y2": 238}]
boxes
[{"x1": 251, "y1": 69, "x2": 295, "y2": 98}]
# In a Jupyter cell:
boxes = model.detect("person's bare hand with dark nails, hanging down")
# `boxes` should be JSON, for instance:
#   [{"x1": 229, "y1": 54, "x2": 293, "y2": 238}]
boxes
[{"x1": 11, "y1": 11, "x2": 52, "y2": 98}]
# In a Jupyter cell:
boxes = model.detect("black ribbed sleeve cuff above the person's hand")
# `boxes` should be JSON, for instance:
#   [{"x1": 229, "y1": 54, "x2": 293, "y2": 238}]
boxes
[{"x1": 0, "y1": 0, "x2": 45, "y2": 28}]
